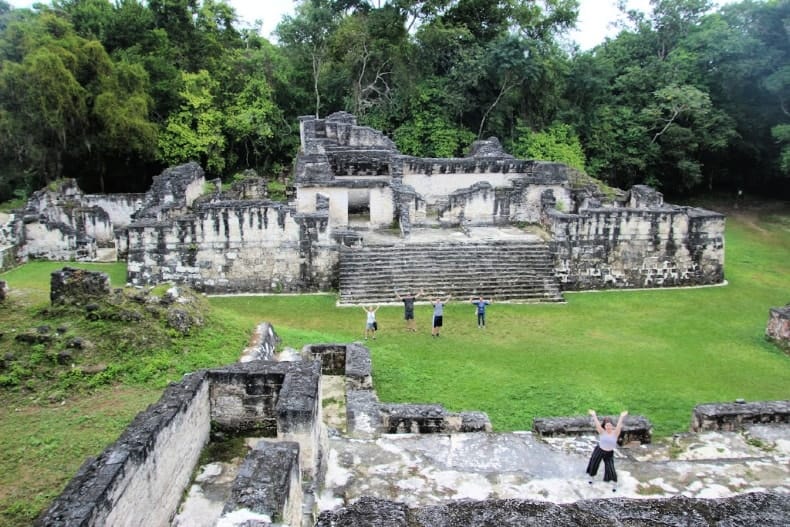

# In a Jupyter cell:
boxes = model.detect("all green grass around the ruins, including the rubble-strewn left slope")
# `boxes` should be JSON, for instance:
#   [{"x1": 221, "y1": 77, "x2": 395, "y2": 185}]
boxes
[{"x1": 0, "y1": 207, "x2": 790, "y2": 527}]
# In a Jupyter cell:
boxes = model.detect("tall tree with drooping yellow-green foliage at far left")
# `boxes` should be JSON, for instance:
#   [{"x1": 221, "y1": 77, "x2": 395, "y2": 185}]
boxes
[{"x1": 0, "y1": 10, "x2": 155, "y2": 194}]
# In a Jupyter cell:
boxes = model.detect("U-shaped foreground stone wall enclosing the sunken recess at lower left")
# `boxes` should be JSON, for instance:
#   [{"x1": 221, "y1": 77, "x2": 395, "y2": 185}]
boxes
[{"x1": 36, "y1": 361, "x2": 321, "y2": 527}]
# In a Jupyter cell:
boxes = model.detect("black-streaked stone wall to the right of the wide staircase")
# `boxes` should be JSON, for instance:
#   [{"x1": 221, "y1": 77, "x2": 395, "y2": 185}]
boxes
[{"x1": 543, "y1": 207, "x2": 724, "y2": 291}]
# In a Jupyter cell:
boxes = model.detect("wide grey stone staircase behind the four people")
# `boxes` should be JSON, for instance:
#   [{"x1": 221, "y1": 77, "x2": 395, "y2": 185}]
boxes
[{"x1": 339, "y1": 241, "x2": 564, "y2": 304}]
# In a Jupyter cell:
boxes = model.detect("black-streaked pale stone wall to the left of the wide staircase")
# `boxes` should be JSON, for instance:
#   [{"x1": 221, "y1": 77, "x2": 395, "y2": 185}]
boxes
[{"x1": 126, "y1": 200, "x2": 337, "y2": 293}]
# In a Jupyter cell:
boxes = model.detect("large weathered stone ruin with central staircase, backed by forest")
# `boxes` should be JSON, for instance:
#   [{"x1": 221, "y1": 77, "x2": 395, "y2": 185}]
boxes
[{"x1": 0, "y1": 112, "x2": 724, "y2": 303}]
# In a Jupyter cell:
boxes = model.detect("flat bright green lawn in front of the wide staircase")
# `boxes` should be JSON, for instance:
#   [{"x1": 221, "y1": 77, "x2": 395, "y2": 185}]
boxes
[{"x1": 211, "y1": 207, "x2": 790, "y2": 436}]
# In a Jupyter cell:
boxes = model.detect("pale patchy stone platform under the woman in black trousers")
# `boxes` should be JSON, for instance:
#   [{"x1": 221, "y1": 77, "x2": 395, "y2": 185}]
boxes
[{"x1": 319, "y1": 425, "x2": 790, "y2": 510}]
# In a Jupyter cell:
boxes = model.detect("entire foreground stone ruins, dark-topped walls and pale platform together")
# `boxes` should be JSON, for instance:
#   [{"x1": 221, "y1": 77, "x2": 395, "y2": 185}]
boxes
[{"x1": 36, "y1": 324, "x2": 790, "y2": 527}]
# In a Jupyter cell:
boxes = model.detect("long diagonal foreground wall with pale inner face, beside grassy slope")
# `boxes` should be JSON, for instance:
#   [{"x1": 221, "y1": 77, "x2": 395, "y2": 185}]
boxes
[{"x1": 36, "y1": 373, "x2": 210, "y2": 527}]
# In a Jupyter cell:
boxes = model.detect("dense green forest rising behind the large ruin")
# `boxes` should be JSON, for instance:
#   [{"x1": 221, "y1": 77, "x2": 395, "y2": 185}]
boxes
[{"x1": 0, "y1": 0, "x2": 790, "y2": 201}]
